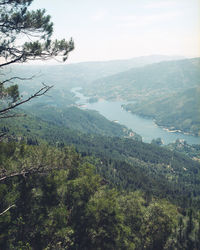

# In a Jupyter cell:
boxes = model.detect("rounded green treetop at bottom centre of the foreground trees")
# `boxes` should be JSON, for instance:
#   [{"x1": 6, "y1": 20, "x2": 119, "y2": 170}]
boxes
[{"x1": 86, "y1": 189, "x2": 134, "y2": 249}]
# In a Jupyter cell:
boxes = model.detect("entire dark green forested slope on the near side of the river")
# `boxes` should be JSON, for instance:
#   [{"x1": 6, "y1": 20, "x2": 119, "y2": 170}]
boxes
[{"x1": 1, "y1": 108, "x2": 200, "y2": 249}]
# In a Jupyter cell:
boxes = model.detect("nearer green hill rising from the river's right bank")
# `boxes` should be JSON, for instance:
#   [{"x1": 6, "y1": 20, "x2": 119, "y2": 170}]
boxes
[{"x1": 123, "y1": 87, "x2": 200, "y2": 136}]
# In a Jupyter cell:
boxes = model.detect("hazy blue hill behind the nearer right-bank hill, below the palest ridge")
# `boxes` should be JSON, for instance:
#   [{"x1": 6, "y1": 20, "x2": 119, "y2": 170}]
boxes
[{"x1": 81, "y1": 58, "x2": 200, "y2": 100}]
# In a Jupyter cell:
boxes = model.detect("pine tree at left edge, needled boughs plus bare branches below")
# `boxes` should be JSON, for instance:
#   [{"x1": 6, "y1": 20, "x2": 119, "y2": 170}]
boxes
[{"x1": 0, "y1": 0, "x2": 74, "y2": 119}]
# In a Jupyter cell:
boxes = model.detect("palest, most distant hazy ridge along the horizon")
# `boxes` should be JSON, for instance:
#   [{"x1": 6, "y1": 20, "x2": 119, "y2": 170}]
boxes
[{"x1": 5, "y1": 55, "x2": 182, "y2": 90}]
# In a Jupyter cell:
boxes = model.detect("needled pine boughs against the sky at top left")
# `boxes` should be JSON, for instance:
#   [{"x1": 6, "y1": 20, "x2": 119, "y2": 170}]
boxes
[{"x1": 0, "y1": 0, "x2": 74, "y2": 67}]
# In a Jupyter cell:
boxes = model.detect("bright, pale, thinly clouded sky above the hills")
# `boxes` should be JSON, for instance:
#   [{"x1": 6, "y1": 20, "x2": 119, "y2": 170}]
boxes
[{"x1": 32, "y1": 0, "x2": 200, "y2": 63}]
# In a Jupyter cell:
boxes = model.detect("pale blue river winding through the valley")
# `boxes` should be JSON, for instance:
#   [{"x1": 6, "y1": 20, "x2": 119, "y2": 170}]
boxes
[{"x1": 71, "y1": 88, "x2": 200, "y2": 144}]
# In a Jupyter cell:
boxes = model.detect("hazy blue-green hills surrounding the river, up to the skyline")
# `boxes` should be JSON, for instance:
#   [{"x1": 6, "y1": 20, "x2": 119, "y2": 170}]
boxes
[{"x1": 2, "y1": 55, "x2": 200, "y2": 138}]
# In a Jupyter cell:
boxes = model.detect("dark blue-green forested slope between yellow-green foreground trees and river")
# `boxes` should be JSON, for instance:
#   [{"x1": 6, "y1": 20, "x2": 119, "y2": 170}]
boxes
[{"x1": 1, "y1": 110, "x2": 200, "y2": 206}]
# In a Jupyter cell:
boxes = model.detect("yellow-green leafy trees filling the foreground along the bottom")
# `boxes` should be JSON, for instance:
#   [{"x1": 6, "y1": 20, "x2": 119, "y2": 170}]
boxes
[{"x1": 0, "y1": 142, "x2": 199, "y2": 250}]
